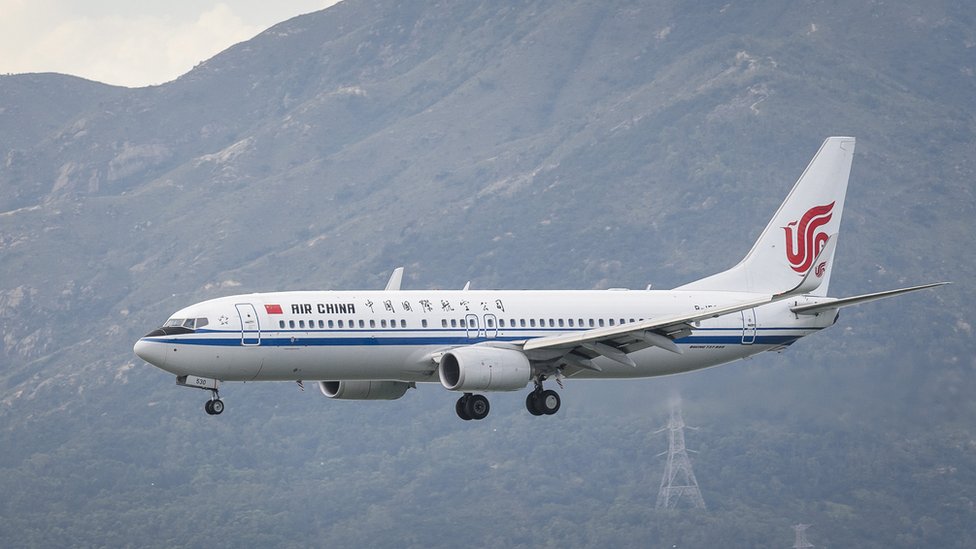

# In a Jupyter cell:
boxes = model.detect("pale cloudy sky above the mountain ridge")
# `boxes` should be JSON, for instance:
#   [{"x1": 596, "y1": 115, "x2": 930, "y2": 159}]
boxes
[{"x1": 0, "y1": 0, "x2": 339, "y2": 87}]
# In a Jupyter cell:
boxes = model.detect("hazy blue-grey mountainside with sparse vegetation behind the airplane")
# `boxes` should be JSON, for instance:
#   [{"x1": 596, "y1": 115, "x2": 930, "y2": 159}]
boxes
[{"x1": 0, "y1": 0, "x2": 976, "y2": 547}]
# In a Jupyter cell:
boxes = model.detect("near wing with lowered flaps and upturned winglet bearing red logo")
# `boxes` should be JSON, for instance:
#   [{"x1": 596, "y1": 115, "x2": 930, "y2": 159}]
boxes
[{"x1": 522, "y1": 235, "x2": 837, "y2": 371}]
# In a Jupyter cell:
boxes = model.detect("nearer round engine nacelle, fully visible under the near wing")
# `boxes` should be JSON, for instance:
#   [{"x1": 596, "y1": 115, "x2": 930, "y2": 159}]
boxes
[{"x1": 437, "y1": 346, "x2": 532, "y2": 392}]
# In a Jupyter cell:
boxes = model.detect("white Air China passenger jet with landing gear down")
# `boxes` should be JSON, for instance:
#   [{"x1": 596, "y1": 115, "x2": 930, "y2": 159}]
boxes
[{"x1": 134, "y1": 137, "x2": 945, "y2": 420}]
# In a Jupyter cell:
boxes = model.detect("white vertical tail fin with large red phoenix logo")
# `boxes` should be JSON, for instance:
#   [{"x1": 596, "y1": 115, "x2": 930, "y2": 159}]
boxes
[{"x1": 676, "y1": 137, "x2": 854, "y2": 296}]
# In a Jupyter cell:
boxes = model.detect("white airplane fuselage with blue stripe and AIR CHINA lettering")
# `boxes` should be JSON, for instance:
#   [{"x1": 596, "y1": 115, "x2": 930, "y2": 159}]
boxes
[{"x1": 130, "y1": 290, "x2": 835, "y2": 382}]
